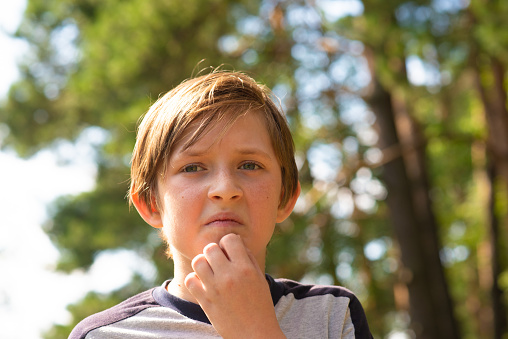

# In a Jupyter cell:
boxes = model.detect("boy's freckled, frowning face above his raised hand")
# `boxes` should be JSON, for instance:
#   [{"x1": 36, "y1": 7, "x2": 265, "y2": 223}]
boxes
[{"x1": 158, "y1": 112, "x2": 293, "y2": 269}]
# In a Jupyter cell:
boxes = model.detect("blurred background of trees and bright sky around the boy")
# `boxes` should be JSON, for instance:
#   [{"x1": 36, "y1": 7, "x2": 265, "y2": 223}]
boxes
[{"x1": 0, "y1": 0, "x2": 508, "y2": 339}]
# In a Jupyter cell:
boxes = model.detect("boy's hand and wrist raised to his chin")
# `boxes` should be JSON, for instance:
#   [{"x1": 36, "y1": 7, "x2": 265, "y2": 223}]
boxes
[{"x1": 185, "y1": 234, "x2": 285, "y2": 338}]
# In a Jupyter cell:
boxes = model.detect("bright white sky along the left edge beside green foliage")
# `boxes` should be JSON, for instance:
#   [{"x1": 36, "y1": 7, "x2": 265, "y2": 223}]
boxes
[{"x1": 0, "y1": 0, "x2": 147, "y2": 339}]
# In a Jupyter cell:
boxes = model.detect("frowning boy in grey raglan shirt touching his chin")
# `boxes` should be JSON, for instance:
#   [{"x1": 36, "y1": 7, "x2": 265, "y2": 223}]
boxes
[{"x1": 70, "y1": 72, "x2": 372, "y2": 339}]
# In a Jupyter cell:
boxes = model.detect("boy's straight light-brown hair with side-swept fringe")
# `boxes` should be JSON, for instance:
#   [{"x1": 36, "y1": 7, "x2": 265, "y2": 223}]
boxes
[{"x1": 129, "y1": 71, "x2": 298, "y2": 215}]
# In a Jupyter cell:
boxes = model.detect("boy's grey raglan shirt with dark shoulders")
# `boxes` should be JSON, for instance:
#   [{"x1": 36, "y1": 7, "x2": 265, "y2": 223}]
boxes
[{"x1": 69, "y1": 275, "x2": 372, "y2": 339}]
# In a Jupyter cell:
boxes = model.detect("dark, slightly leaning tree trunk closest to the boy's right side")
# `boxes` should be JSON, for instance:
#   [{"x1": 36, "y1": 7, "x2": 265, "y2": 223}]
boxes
[{"x1": 364, "y1": 47, "x2": 459, "y2": 339}]
